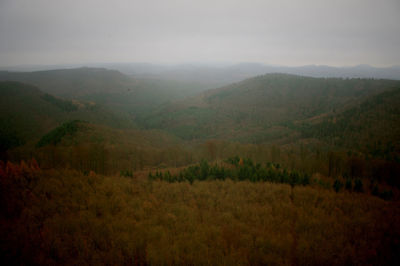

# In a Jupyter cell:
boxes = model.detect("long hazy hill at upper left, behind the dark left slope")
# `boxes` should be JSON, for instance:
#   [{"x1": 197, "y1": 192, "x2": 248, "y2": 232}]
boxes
[{"x1": 0, "y1": 67, "x2": 209, "y2": 118}]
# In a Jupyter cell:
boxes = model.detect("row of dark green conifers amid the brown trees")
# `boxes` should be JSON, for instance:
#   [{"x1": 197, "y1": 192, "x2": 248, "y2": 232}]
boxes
[{"x1": 148, "y1": 156, "x2": 394, "y2": 200}]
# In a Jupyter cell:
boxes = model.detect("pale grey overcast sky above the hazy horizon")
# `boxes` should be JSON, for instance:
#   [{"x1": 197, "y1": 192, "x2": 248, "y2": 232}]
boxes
[{"x1": 0, "y1": 0, "x2": 400, "y2": 66}]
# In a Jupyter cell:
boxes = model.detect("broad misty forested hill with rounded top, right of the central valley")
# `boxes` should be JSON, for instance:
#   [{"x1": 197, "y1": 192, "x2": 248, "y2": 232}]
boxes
[{"x1": 142, "y1": 74, "x2": 400, "y2": 142}]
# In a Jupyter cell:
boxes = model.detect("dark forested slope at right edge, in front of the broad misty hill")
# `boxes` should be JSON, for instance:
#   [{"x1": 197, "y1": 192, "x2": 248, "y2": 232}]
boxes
[{"x1": 300, "y1": 87, "x2": 400, "y2": 160}]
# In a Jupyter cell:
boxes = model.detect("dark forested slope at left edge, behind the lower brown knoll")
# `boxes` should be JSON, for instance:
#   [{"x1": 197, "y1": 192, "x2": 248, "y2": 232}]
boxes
[{"x1": 0, "y1": 81, "x2": 133, "y2": 150}]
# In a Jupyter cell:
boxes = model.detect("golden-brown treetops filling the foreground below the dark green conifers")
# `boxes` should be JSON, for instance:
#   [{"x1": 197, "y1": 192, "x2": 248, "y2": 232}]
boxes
[{"x1": 0, "y1": 169, "x2": 400, "y2": 265}]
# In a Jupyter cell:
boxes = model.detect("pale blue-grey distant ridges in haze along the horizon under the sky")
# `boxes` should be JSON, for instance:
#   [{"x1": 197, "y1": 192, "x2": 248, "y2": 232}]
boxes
[{"x1": 1, "y1": 62, "x2": 400, "y2": 83}]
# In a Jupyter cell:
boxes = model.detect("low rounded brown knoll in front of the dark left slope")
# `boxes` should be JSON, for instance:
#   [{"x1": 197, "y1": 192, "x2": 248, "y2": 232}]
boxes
[{"x1": 28, "y1": 121, "x2": 188, "y2": 174}]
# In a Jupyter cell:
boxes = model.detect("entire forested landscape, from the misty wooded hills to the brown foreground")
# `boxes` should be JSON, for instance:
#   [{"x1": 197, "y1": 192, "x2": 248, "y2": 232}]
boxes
[{"x1": 0, "y1": 67, "x2": 400, "y2": 265}]
